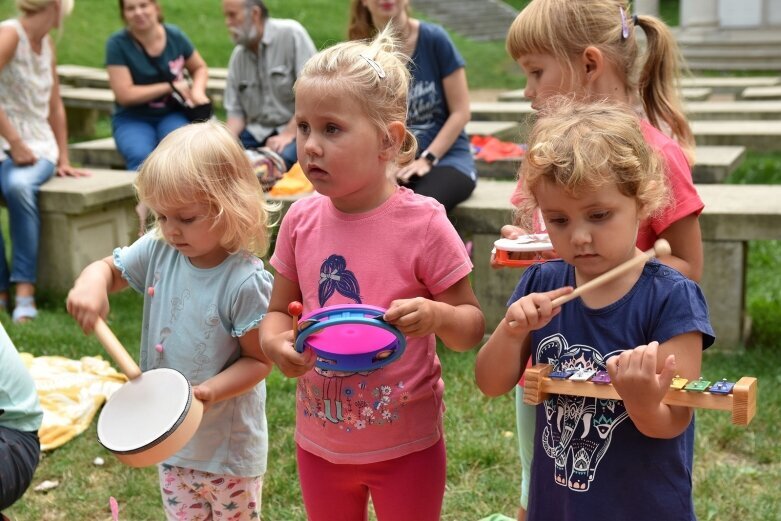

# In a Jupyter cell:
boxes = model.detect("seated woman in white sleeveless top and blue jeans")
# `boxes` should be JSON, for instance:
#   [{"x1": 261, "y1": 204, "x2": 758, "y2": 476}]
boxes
[{"x1": 0, "y1": 0, "x2": 84, "y2": 322}]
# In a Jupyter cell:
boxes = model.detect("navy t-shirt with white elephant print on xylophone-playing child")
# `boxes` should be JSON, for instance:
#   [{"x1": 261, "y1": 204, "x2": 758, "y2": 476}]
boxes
[{"x1": 510, "y1": 260, "x2": 714, "y2": 521}]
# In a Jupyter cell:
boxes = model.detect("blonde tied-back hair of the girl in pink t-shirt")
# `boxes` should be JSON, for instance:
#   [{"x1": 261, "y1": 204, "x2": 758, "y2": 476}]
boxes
[{"x1": 295, "y1": 26, "x2": 418, "y2": 165}]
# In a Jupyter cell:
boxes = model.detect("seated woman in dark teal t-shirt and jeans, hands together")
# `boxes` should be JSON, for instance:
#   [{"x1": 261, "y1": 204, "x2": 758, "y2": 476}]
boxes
[{"x1": 106, "y1": 0, "x2": 208, "y2": 170}]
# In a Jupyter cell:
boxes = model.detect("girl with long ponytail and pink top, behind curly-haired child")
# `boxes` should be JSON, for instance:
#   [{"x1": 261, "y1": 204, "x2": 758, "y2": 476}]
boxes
[{"x1": 494, "y1": 0, "x2": 704, "y2": 520}]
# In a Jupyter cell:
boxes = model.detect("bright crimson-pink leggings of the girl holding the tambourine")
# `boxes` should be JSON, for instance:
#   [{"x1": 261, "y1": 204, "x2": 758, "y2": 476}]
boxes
[{"x1": 296, "y1": 438, "x2": 447, "y2": 521}]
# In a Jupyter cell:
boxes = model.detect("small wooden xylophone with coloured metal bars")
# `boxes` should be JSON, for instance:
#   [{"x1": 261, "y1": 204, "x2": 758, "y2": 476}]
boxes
[{"x1": 523, "y1": 364, "x2": 757, "y2": 425}]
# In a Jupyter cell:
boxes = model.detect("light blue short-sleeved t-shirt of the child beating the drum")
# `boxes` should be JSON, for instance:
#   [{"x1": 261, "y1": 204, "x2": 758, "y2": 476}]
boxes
[{"x1": 114, "y1": 232, "x2": 273, "y2": 477}]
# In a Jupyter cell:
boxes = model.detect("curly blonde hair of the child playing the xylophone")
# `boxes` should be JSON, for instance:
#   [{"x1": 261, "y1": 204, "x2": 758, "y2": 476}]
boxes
[{"x1": 516, "y1": 97, "x2": 670, "y2": 229}]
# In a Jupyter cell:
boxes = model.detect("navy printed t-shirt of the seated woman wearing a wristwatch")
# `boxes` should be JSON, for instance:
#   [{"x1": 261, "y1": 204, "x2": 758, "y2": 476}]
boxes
[{"x1": 407, "y1": 22, "x2": 477, "y2": 179}]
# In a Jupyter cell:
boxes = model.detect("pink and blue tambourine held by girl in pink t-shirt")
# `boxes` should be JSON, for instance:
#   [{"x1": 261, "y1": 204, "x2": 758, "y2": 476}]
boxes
[{"x1": 295, "y1": 304, "x2": 407, "y2": 372}]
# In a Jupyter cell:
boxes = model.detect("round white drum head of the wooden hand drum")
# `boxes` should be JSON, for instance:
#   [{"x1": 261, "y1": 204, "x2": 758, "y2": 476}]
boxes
[{"x1": 98, "y1": 368, "x2": 192, "y2": 454}]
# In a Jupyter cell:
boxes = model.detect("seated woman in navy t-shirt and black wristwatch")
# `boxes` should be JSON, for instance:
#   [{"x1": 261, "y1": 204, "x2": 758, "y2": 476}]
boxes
[{"x1": 348, "y1": 0, "x2": 477, "y2": 211}]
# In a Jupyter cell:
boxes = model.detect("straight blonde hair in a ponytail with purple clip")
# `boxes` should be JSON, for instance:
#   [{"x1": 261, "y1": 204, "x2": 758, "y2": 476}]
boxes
[{"x1": 507, "y1": 0, "x2": 695, "y2": 163}]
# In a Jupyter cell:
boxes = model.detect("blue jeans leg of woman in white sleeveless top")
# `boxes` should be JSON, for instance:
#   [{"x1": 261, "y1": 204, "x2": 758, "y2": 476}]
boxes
[{"x1": 0, "y1": 159, "x2": 54, "y2": 290}]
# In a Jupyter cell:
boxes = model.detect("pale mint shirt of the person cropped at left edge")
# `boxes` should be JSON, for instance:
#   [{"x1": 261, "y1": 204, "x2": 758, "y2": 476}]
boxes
[{"x1": 0, "y1": 324, "x2": 43, "y2": 432}]
